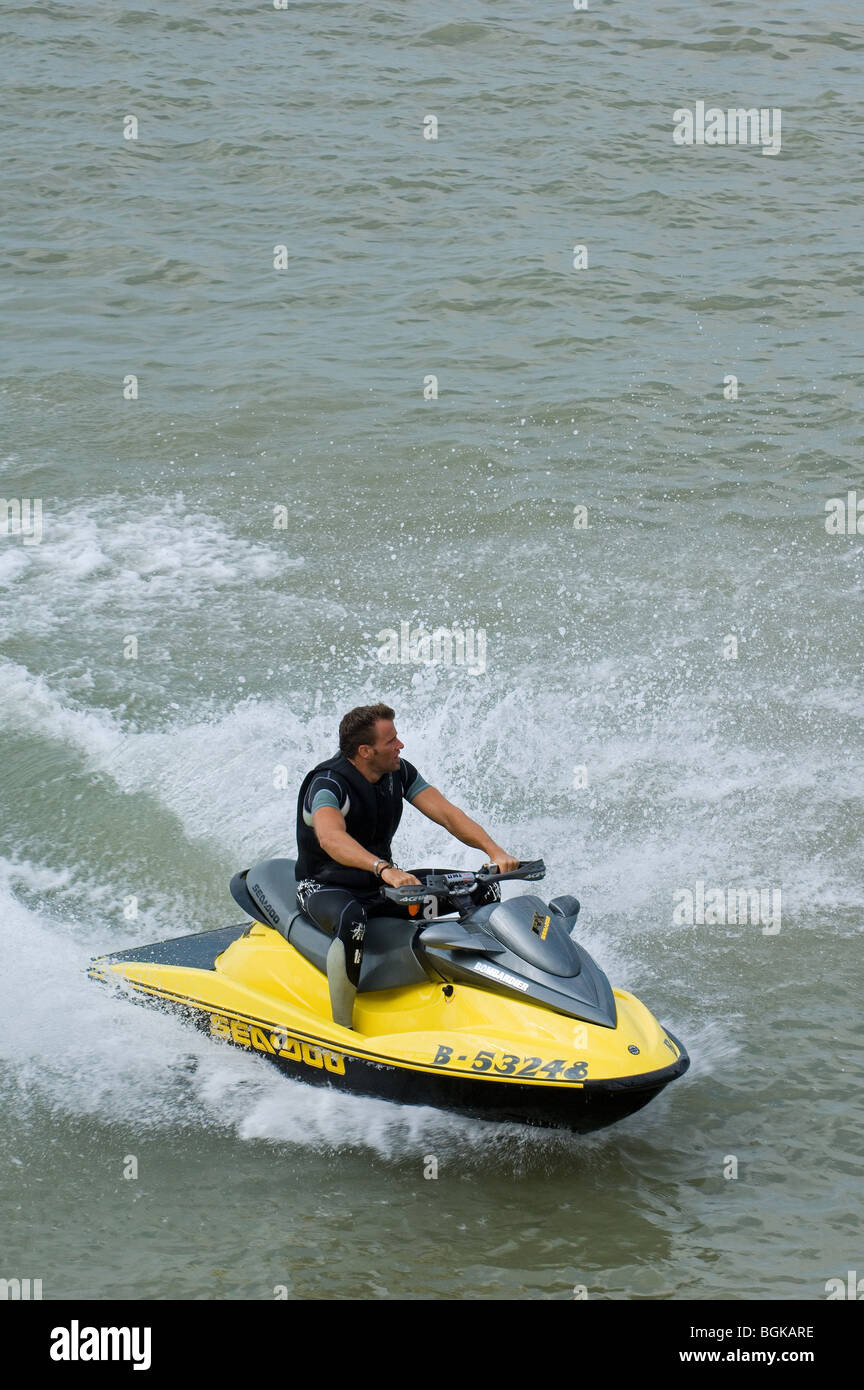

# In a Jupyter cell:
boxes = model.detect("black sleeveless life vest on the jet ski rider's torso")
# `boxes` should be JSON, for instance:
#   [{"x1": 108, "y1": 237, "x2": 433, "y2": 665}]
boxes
[{"x1": 296, "y1": 753, "x2": 406, "y2": 892}]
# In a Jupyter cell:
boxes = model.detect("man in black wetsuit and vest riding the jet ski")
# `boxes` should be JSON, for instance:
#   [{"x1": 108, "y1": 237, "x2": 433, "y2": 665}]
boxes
[{"x1": 296, "y1": 705, "x2": 520, "y2": 1029}]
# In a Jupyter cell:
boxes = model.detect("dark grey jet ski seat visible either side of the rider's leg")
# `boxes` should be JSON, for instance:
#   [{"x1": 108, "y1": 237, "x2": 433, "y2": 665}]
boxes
[{"x1": 231, "y1": 859, "x2": 429, "y2": 994}]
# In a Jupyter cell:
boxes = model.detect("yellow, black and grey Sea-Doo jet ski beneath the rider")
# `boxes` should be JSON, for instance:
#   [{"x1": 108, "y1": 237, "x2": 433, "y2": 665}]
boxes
[{"x1": 90, "y1": 859, "x2": 690, "y2": 1134}]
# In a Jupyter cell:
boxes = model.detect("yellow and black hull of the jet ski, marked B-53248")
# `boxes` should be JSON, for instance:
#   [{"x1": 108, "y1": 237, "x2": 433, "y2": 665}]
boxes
[{"x1": 90, "y1": 922, "x2": 689, "y2": 1133}]
